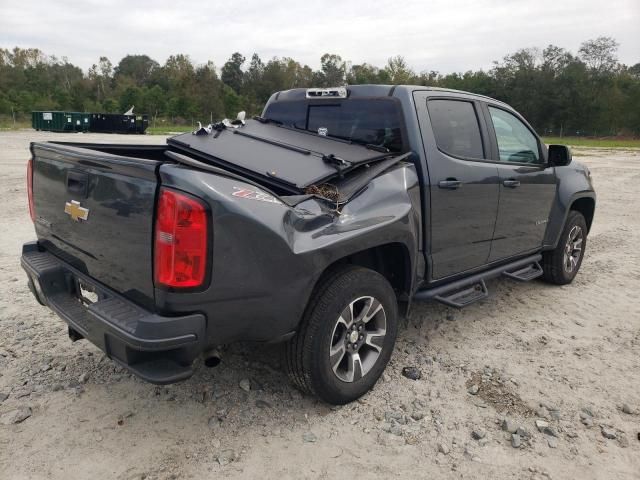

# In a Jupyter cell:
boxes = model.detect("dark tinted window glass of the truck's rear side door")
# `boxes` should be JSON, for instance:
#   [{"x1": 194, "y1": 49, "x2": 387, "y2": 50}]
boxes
[{"x1": 427, "y1": 100, "x2": 484, "y2": 159}]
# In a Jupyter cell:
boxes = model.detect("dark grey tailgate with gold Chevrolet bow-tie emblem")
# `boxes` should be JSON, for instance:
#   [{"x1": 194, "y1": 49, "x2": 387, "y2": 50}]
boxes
[{"x1": 31, "y1": 143, "x2": 161, "y2": 308}]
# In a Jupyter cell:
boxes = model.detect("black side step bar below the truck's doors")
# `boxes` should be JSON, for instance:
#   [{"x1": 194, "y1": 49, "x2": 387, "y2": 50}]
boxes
[{"x1": 413, "y1": 254, "x2": 542, "y2": 308}]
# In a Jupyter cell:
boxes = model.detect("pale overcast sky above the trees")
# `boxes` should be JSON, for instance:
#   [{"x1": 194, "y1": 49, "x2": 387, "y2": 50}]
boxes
[{"x1": 0, "y1": 0, "x2": 640, "y2": 73}]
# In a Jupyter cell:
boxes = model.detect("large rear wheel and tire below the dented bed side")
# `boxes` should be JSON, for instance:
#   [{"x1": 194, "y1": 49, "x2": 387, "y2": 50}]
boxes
[{"x1": 285, "y1": 266, "x2": 398, "y2": 405}]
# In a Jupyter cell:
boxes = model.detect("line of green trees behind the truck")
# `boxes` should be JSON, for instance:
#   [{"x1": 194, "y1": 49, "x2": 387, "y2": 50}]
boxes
[{"x1": 0, "y1": 37, "x2": 640, "y2": 136}]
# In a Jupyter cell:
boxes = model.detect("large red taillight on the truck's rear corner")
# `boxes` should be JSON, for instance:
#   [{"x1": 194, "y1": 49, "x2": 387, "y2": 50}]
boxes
[{"x1": 154, "y1": 188, "x2": 208, "y2": 288}]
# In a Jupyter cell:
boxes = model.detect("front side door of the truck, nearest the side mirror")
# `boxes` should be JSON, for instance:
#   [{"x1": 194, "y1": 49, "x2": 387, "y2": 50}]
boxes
[{"x1": 483, "y1": 103, "x2": 557, "y2": 261}]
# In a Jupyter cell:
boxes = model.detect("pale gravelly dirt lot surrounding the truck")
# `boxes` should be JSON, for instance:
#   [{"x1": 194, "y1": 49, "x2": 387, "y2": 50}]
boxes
[{"x1": 0, "y1": 131, "x2": 640, "y2": 480}]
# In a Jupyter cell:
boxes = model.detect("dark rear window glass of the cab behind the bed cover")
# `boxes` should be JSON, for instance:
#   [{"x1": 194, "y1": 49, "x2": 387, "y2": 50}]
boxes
[{"x1": 264, "y1": 98, "x2": 403, "y2": 152}]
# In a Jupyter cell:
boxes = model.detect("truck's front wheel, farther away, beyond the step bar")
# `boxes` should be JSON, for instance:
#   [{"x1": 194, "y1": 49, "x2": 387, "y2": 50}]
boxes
[{"x1": 542, "y1": 210, "x2": 587, "y2": 285}]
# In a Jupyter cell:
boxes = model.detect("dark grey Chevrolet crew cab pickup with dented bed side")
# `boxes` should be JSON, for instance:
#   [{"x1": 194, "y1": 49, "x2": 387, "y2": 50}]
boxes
[{"x1": 21, "y1": 85, "x2": 595, "y2": 404}]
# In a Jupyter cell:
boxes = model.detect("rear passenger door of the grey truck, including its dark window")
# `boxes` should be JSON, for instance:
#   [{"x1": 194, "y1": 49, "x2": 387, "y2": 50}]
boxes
[{"x1": 414, "y1": 91, "x2": 499, "y2": 280}]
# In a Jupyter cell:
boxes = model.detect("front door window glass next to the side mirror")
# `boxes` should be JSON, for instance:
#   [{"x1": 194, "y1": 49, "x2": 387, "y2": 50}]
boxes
[{"x1": 489, "y1": 107, "x2": 541, "y2": 163}]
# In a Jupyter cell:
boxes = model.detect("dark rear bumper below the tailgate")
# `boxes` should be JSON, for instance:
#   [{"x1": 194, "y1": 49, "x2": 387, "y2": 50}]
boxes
[{"x1": 20, "y1": 242, "x2": 206, "y2": 384}]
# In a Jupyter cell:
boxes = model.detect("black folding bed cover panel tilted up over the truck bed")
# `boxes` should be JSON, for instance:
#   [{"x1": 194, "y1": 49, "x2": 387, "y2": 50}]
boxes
[{"x1": 167, "y1": 120, "x2": 405, "y2": 195}]
